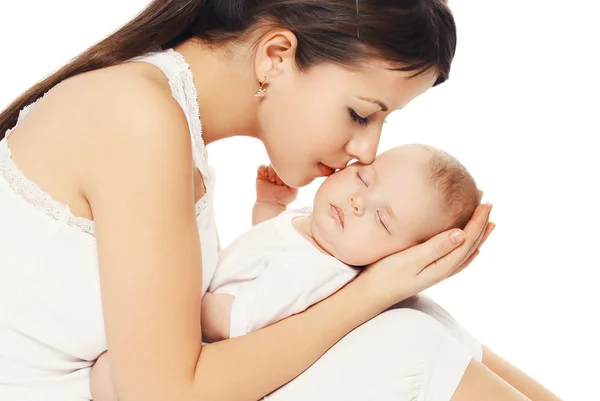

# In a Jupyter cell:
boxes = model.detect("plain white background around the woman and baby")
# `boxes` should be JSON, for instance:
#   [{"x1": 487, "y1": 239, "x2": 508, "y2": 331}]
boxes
[{"x1": 0, "y1": 0, "x2": 600, "y2": 400}]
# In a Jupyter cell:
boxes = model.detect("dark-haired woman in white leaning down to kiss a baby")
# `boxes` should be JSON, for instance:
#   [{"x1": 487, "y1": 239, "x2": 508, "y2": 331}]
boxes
[{"x1": 0, "y1": 0, "x2": 551, "y2": 401}]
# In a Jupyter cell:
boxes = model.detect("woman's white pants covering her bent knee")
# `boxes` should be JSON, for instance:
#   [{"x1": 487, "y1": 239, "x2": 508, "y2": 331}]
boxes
[{"x1": 264, "y1": 295, "x2": 482, "y2": 401}]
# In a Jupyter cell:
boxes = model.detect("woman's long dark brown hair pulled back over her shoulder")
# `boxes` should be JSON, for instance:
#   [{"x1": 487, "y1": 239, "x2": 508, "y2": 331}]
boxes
[{"x1": 0, "y1": 0, "x2": 456, "y2": 140}]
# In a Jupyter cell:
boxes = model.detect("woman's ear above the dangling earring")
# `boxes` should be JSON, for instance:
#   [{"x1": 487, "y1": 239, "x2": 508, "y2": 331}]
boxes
[{"x1": 254, "y1": 29, "x2": 298, "y2": 83}]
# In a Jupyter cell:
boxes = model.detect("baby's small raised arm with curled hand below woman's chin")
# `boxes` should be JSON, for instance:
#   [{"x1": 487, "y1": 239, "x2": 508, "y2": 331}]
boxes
[{"x1": 252, "y1": 166, "x2": 298, "y2": 226}]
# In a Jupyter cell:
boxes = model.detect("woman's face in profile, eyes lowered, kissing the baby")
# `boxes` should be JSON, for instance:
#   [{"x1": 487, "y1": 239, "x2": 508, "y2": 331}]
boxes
[{"x1": 259, "y1": 61, "x2": 436, "y2": 187}]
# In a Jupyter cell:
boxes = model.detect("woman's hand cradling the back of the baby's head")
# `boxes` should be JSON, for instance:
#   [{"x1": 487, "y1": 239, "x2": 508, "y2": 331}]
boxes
[{"x1": 356, "y1": 204, "x2": 495, "y2": 310}]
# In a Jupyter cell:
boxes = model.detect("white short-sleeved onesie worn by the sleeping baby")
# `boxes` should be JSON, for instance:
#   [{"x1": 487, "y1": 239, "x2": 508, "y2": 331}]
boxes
[{"x1": 208, "y1": 211, "x2": 359, "y2": 338}]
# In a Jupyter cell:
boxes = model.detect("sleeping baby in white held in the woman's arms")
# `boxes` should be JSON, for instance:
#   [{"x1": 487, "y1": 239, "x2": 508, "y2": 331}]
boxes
[{"x1": 92, "y1": 145, "x2": 479, "y2": 401}]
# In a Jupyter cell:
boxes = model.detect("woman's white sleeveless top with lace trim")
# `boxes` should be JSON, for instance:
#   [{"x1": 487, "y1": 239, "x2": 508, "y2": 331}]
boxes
[{"x1": 0, "y1": 49, "x2": 217, "y2": 401}]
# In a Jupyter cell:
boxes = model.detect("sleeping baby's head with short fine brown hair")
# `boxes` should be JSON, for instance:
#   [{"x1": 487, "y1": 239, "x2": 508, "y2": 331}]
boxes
[{"x1": 311, "y1": 145, "x2": 479, "y2": 266}]
